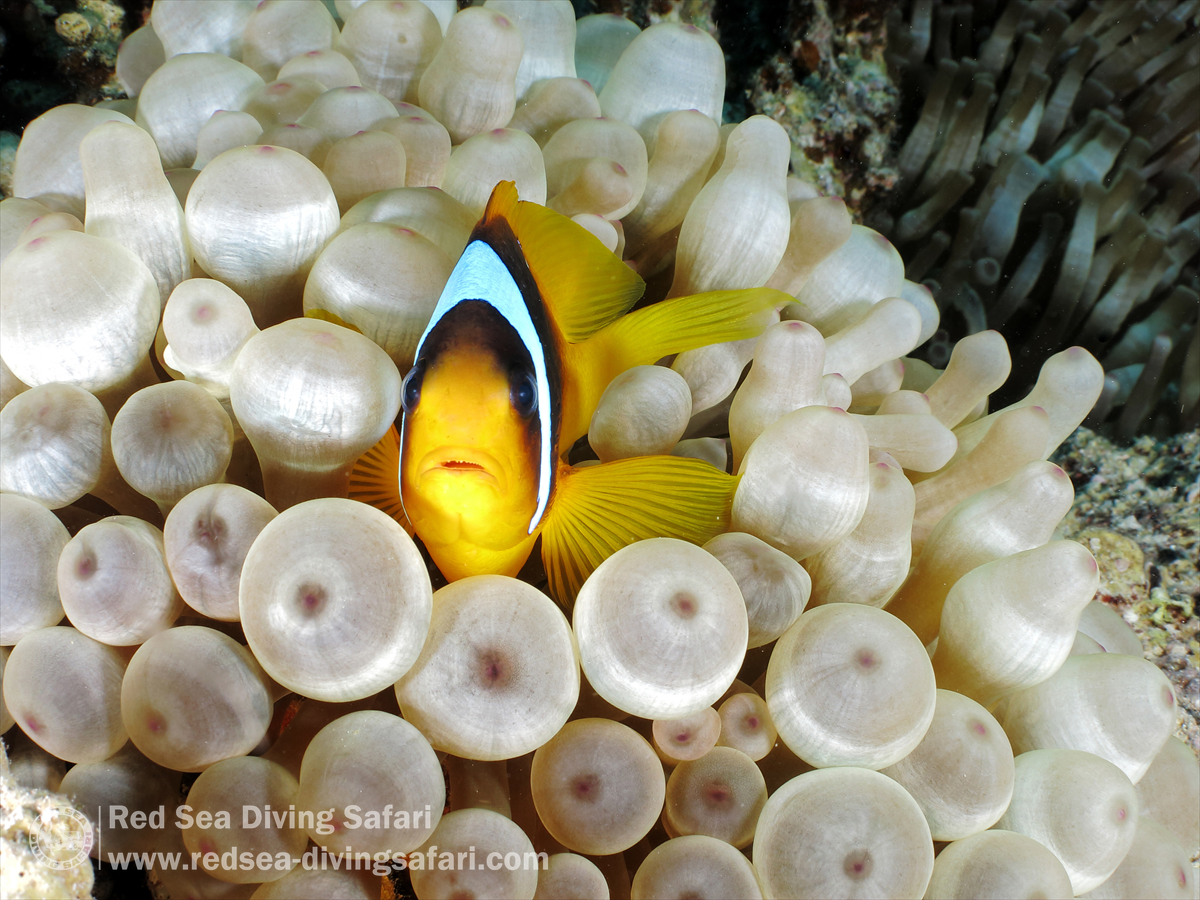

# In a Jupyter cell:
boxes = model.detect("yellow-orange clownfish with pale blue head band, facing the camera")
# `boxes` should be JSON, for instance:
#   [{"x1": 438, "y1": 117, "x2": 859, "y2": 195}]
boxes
[{"x1": 349, "y1": 181, "x2": 792, "y2": 600}]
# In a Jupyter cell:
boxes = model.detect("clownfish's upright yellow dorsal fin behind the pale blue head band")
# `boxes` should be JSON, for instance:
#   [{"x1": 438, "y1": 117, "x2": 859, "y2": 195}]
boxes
[{"x1": 484, "y1": 181, "x2": 646, "y2": 343}]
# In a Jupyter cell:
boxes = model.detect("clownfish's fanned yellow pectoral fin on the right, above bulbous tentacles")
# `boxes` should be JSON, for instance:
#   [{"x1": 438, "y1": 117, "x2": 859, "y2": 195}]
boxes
[{"x1": 541, "y1": 456, "x2": 738, "y2": 606}]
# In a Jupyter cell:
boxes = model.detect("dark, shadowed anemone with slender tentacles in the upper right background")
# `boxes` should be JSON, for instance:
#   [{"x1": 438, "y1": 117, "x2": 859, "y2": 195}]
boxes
[{"x1": 876, "y1": 0, "x2": 1200, "y2": 439}]
